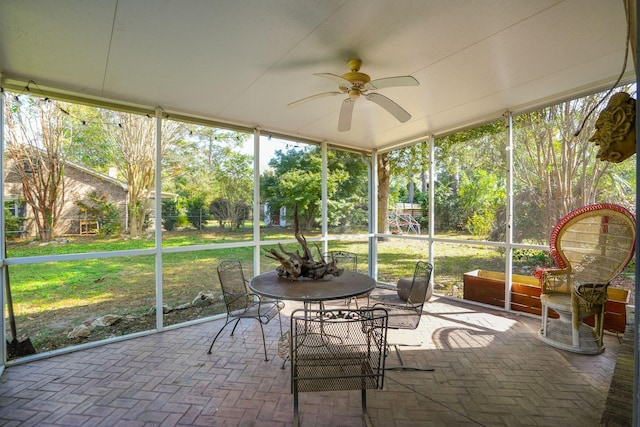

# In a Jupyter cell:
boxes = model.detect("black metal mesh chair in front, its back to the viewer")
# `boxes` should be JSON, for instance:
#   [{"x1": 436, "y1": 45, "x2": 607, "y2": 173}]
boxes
[{"x1": 290, "y1": 308, "x2": 388, "y2": 426}]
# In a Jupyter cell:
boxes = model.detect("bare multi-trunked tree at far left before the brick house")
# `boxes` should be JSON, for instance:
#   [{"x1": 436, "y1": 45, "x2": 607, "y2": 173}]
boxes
[{"x1": 5, "y1": 96, "x2": 71, "y2": 240}]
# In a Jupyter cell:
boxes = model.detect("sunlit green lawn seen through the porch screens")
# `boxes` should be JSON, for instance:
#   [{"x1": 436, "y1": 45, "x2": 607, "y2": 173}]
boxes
[{"x1": 7, "y1": 227, "x2": 552, "y2": 360}]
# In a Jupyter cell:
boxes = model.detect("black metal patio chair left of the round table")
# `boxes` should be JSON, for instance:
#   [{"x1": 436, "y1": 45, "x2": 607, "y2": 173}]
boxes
[{"x1": 208, "y1": 260, "x2": 284, "y2": 361}]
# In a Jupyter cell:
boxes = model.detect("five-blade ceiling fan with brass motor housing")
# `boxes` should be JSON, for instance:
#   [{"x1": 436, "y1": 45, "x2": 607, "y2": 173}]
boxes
[{"x1": 288, "y1": 59, "x2": 420, "y2": 132}]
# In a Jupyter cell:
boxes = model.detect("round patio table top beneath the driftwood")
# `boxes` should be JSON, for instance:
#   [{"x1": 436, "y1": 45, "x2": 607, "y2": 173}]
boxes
[{"x1": 249, "y1": 270, "x2": 376, "y2": 302}]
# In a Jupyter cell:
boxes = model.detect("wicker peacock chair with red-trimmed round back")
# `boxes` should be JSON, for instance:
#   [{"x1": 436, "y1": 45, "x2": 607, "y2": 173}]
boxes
[{"x1": 536, "y1": 203, "x2": 636, "y2": 354}]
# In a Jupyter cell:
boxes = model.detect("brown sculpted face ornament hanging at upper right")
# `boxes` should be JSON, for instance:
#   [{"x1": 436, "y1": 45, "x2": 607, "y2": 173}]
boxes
[{"x1": 589, "y1": 92, "x2": 636, "y2": 163}]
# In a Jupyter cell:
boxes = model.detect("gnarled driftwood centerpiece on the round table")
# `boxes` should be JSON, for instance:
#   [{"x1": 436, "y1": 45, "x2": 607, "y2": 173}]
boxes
[{"x1": 266, "y1": 205, "x2": 344, "y2": 280}]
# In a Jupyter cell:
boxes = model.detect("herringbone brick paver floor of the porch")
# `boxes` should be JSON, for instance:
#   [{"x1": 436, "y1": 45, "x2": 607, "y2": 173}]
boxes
[{"x1": 0, "y1": 297, "x2": 620, "y2": 427}]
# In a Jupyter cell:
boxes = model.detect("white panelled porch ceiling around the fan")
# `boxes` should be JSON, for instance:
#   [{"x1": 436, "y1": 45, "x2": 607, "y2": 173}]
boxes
[{"x1": 0, "y1": 0, "x2": 632, "y2": 150}]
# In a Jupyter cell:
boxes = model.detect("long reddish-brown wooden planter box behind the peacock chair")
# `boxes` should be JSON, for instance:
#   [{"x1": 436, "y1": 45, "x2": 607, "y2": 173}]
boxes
[{"x1": 463, "y1": 270, "x2": 629, "y2": 333}]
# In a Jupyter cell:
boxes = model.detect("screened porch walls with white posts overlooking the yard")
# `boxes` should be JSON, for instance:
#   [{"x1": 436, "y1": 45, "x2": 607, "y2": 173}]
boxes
[{"x1": 2, "y1": 83, "x2": 636, "y2": 362}]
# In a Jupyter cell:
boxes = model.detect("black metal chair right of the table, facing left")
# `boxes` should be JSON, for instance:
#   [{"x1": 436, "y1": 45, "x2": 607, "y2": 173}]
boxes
[{"x1": 367, "y1": 261, "x2": 433, "y2": 371}]
